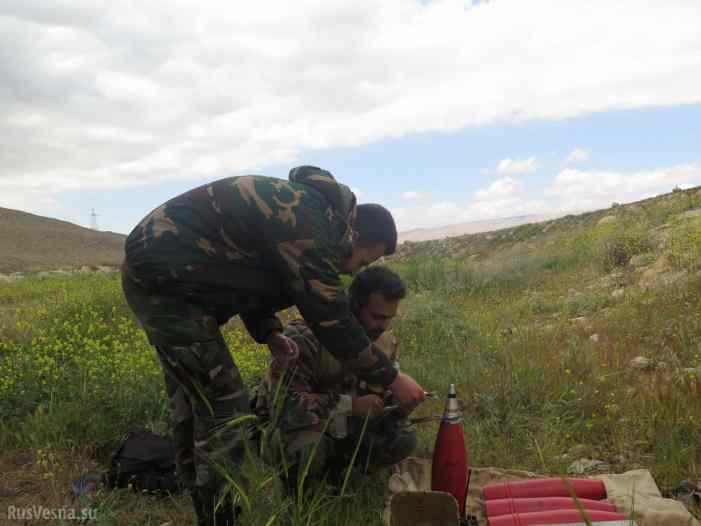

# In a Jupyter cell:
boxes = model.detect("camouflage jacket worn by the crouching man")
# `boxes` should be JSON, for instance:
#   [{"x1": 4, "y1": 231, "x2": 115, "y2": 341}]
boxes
[{"x1": 256, "y1": 320, "x2": 398, "y2": 438}]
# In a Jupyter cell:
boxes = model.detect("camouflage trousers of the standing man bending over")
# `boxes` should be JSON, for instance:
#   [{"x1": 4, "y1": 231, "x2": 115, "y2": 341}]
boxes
[{"x1": 122, "y1": 272, "x2": 250, "y2": 494}]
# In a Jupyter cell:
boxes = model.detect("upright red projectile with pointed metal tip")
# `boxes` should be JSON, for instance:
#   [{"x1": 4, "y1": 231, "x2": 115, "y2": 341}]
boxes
[{"x1": 431, "y1": 384, "x2": 469, "y2": 517}]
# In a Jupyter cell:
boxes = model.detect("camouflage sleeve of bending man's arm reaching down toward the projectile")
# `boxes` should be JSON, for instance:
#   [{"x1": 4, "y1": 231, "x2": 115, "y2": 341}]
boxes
[{"x1": 278, "y1": 240, "x2": 397, "y2": 386}]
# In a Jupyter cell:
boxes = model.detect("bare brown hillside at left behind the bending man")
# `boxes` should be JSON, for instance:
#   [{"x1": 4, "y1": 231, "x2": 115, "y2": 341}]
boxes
[{"x1": 0, "y1": 208, "x2": 125, "y2": 273}]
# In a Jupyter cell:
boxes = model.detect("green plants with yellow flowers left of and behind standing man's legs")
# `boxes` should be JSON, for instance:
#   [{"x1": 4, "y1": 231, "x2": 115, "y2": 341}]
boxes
[{"x1": 0, "y1": 274, "x2": 267, "y2": 447}]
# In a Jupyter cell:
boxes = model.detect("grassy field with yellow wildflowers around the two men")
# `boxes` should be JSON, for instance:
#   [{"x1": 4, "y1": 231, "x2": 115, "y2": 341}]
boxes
[{"x1": 0, "y1": 188, "x2": 701, "y2": 526}]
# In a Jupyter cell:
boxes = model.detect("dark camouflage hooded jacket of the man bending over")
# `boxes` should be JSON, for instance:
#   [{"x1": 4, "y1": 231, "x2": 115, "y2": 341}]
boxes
[{"x1": 125, "y1": 166, "x2": 396, "y2": 385}]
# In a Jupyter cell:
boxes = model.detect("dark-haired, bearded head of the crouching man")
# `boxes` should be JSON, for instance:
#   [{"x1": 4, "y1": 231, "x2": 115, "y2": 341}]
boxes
[{"x1": 348, "y1": 265, "x2": 406, "y2": 341}]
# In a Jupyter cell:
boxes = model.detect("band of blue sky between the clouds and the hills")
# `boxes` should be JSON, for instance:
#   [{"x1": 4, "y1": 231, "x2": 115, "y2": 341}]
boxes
[{"x1": 53, "y1": 105, "x2": 701, "y2": 233}]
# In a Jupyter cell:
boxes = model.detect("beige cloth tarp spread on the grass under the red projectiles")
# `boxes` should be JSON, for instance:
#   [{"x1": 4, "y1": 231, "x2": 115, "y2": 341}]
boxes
[{"x1": 384, "y1": 457, "x2": 701, "y2": 526}]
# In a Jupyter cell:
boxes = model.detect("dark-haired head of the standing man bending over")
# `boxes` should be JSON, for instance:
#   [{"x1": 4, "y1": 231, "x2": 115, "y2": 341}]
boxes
[{"x1": 341, "y1": 203, "x2": 397, "y2": 274}]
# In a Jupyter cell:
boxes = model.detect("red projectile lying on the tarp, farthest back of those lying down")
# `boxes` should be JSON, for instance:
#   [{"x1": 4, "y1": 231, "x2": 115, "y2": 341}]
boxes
[{"x1": 484, "y1": 478, "x2": 606, "y2": 500}]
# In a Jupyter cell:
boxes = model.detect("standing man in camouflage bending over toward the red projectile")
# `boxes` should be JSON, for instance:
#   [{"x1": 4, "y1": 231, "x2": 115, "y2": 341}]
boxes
[{"x1": 122, "y1": 166, "x2": 424, "y2": 526}]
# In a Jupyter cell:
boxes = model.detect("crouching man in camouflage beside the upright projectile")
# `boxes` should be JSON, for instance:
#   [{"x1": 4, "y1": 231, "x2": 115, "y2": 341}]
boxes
[{"x1": 256, "y1": 266, "x2": 416, "y2": 493}]
